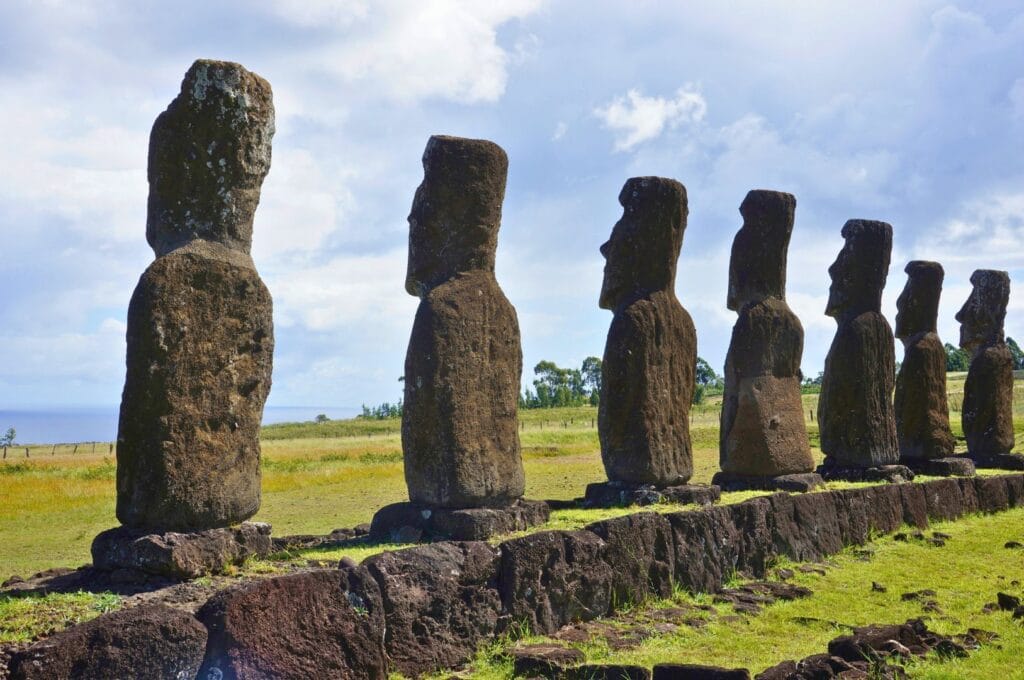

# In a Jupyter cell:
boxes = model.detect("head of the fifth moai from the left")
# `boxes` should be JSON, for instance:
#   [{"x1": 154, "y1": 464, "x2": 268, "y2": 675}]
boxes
[{"x1": 825, "y1": 219, "x2": 893, "y2": 320}]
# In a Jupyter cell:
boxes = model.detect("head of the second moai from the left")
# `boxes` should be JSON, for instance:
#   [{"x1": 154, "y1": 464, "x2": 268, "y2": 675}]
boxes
[{"x1": 406, "y1": 135, "x2": 509, "y2": 297}]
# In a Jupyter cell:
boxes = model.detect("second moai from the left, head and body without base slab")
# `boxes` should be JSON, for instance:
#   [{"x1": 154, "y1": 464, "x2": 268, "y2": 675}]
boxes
[{"x1": 401, "y1": 136, "x2": 525, "y2": 508}]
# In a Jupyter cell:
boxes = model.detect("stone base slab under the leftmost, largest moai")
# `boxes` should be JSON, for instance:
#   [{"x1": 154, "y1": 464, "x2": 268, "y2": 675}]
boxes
[{"x1": 92, "y1": 522, "x2": 273, "y2": 579}]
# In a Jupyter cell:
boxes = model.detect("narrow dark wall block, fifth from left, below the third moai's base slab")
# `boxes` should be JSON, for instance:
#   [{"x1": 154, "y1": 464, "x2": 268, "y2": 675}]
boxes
[{"x1": 587, "y1": 512, "x2": 676, "y2": 605}]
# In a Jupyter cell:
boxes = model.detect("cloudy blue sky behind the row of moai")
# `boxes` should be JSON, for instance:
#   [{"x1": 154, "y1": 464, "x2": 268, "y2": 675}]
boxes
[{"x1": 0, "y1": 0, "x2": 1024, "y2": 408}]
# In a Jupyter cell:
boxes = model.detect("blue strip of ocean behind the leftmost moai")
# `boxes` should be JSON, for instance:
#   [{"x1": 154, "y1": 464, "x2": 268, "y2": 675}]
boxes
[{"x1": 0, "y1": 406, "x2": 361, "y2": 445}]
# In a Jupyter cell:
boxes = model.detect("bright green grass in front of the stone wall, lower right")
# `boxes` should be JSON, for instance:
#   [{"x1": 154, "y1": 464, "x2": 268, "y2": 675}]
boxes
[{"x1": 438, "y1": 509, "x2": 1024, "y2": 680}]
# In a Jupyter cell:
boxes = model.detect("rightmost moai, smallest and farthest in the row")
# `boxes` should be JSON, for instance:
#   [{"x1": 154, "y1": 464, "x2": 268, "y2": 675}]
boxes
[{"x1": 956, "y1": 269, "x2": 1024, "y2": 469}]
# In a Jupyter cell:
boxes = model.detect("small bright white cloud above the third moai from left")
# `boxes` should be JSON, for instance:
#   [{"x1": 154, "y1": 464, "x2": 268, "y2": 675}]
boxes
[{"x1": 594, "y1": 85, "x2": 708, "y2": 151}]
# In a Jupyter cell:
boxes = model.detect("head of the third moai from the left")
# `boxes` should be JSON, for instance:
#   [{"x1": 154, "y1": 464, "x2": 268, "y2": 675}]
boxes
[{"x1": 600, "y1": 177, "x2": 689, "y2": 309}]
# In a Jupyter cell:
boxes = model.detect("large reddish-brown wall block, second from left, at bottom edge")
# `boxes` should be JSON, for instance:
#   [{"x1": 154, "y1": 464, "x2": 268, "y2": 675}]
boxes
[{"x1": 198, "y1": 567, "x2": 387, "y2": 680}]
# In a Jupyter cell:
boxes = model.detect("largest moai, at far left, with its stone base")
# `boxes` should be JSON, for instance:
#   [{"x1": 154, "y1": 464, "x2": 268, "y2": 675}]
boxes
[{"x1": 93, "y1": 59, "x2": 274, "y2": 571}]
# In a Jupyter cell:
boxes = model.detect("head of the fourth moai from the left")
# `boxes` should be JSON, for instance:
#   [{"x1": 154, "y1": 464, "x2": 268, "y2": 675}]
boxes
[{"x1": 726, "y1": 189, "x2": 797, "y2": 311}]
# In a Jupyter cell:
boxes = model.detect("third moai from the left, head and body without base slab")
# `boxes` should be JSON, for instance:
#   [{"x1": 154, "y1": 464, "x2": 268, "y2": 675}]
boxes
[{"x1": 598, "y1": 177, "x2": 696, "y2": 487}]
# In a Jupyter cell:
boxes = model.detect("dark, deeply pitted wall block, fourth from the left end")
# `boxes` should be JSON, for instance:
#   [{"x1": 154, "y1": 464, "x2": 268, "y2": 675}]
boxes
[{"x1": 499, "y1": 532, "x2": 612, "y2": 634}]
